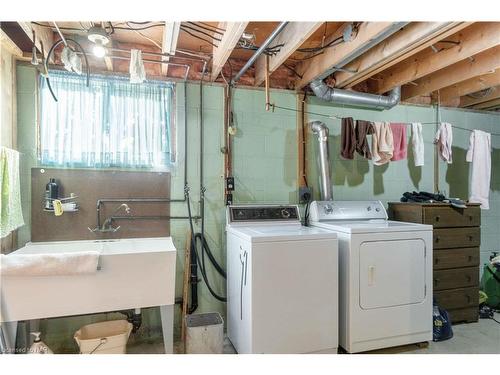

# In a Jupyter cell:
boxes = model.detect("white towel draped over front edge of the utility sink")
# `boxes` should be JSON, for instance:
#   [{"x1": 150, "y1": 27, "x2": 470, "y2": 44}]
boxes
[{"x1": 0, "y1": 251, "x2": 99, "y2": 276}]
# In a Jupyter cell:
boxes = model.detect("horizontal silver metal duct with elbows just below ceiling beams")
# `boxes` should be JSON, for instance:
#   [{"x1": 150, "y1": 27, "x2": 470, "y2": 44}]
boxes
[{"x1": 309, "y1": 79, "x2": 401, "y2": 110}]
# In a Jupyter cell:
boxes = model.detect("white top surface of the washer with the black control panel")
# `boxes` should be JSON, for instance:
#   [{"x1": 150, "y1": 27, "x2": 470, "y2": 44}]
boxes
[{"x1": 226, "y1": 225, "x2": 337, "y2": 243}]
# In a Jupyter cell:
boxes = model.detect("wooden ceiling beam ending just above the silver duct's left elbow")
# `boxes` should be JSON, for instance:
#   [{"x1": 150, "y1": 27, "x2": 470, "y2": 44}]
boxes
[{"x1": 295, "y1": 22, "x2": 405, "y2": 89}]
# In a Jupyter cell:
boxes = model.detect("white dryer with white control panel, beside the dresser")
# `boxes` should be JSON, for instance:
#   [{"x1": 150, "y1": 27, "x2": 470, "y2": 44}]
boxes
[{"x1": 310, "y1": 201, "x2": 432, "y2": 353}]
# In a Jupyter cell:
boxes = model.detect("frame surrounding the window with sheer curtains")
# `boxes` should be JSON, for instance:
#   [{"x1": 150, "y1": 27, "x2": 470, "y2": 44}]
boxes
[{"x1": 36, "y1": 68, "x2": 178, "y2": 172}]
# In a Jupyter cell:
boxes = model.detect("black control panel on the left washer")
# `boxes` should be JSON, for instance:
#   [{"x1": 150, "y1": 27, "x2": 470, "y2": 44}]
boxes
[{"x1": 228, "y1": 205, "x2": 300, "y2": 223}]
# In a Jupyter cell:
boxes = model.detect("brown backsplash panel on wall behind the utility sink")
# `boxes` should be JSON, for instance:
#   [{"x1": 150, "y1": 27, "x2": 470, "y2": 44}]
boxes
[{"x1": 31, "y1": 168, "x2": 170, "y2": 242}]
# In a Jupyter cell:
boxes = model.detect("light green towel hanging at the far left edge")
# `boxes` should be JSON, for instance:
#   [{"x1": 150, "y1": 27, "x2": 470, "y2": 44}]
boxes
[{"x1": 0, "y1": 147, "x2": 24, "y2": 238}]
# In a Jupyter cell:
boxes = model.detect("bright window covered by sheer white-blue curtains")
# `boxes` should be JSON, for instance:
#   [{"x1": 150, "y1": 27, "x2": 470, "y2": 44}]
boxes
[{"x1": 40, "y1": 71, "x2": 175, "y2": 168}]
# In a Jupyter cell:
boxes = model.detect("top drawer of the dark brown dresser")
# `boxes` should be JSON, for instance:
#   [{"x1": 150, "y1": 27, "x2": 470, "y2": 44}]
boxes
[{"x1": 422, "y1": 207, "x2": 481, "y2": 228}]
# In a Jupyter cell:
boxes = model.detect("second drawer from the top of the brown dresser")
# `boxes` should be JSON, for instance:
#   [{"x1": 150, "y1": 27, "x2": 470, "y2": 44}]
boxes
[{"x1": 433, "y1": 227, "x2": 481, "y2": 249}]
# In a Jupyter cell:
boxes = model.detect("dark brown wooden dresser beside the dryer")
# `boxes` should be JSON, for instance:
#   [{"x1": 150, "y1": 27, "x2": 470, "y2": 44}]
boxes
[{"x1": 389, "y1": 202, "x2": 481, "y2": 323}]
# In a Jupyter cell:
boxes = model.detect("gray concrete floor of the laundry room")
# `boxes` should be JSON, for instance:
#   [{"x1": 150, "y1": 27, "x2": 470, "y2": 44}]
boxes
[{"x1": 127, "y1": 313, "x2": 500, "y2": 354}]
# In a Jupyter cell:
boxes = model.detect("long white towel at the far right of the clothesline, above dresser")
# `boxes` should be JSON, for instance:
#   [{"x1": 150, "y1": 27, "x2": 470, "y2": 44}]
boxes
[{"x1": 466, "y1": 130, "x2": 491, "y2": 210}]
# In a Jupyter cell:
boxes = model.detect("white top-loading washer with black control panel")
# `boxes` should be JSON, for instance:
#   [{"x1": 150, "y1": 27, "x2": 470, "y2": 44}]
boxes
[{"x1": 226, "y1": 205, "x2": 338, "y2": 354}]
